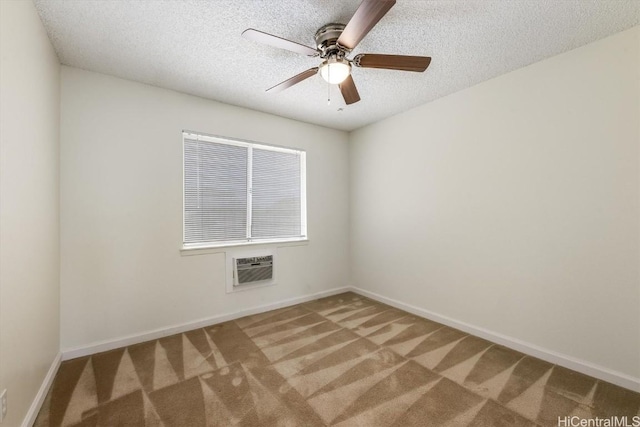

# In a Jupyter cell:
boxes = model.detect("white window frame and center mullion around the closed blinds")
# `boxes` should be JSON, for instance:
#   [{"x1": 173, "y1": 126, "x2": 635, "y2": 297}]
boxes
[{"x1": 182, "y1": 130, "x2": 308, "y2": 250}]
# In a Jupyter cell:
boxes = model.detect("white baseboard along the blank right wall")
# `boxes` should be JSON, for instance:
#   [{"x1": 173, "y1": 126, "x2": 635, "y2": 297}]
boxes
[{"x1": 350, "y1": 287, "x2": 640, "y2": 392}]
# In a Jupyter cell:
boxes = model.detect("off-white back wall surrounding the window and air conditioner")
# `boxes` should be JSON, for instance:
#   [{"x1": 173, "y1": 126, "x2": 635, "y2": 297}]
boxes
[{"x1": 60, "y1": 67, "x2": 349, "y2": 349}]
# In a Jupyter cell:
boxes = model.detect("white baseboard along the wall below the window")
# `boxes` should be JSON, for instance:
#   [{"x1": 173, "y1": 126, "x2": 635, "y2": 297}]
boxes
[{"x1": 62, "y1": 287, "x2": 351, "y2": 360}]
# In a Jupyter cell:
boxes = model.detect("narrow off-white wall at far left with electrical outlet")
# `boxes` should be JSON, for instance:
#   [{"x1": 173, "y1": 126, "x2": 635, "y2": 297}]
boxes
[{"x1": 0, "y1": 1, "x2": 60, "y2": 426}]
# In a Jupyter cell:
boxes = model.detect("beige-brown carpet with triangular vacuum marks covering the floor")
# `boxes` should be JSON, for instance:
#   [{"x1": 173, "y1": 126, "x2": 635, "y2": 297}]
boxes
[{"x1": 35, "y1": 293, "x2": 640, "y2": 427}]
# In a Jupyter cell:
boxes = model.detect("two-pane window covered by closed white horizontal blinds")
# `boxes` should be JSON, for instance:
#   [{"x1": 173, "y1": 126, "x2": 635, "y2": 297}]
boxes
[{"x1": 183, "y1": 132, "x2": 307, "y2": 248}]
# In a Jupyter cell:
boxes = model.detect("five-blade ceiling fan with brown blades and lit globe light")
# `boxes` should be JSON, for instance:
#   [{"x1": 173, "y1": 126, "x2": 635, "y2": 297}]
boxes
[{"x1": 242, "y1": 0, "x2": 431, "y2": 105}]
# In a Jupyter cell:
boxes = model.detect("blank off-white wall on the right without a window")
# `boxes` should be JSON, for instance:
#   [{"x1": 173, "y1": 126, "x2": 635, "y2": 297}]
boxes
[{"x1": 350, "y1": 27, "x2": 640, "y2": 381}]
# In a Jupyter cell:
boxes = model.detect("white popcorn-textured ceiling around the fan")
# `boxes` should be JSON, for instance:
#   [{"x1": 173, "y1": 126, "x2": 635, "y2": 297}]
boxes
[{"x1": 35, "y1": 0, "x2": 640, "y2": 130}]
